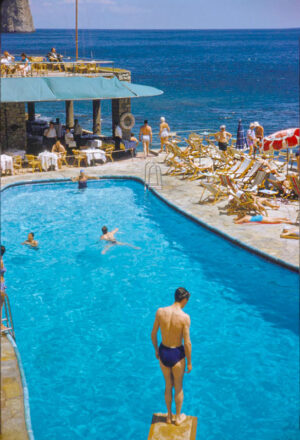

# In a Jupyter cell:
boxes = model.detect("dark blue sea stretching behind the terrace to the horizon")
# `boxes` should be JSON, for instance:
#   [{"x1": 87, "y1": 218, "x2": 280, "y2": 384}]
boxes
[{"x1": 2, "y1": 29, "x2": 300, "y2": 139}]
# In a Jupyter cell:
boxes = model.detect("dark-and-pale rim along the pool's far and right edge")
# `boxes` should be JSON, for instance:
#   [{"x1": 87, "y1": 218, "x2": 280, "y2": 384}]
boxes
[{"x1": 0, "y1": 174, "x2": 300, "y2": 273}]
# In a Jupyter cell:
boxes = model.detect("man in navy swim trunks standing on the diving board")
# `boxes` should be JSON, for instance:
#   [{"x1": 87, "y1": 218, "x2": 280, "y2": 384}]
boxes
[{"x1": 151, "y1": 287, "x2": 192, "y2": 425}]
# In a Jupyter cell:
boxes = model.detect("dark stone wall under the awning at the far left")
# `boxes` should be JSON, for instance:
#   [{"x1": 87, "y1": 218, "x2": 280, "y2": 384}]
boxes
[{"x1": 0, "y1": 103, "x2": 27, "y2": 152}]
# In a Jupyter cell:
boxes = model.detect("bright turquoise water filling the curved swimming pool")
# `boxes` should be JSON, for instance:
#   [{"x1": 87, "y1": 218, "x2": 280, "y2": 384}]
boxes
[{"x1": 1, "y1": 180, "x2": 299, "y2": 440}]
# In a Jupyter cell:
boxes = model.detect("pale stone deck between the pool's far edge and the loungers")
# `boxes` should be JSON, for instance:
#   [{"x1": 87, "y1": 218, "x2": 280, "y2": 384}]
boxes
[{"x1": 1, "y1": 153, "x2": 299, "y2": 267}]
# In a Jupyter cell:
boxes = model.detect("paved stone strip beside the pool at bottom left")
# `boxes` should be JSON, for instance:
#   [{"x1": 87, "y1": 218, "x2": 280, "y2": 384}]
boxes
[{"x1": 0, "y1": 335, "x2": 29, "y2": 440}]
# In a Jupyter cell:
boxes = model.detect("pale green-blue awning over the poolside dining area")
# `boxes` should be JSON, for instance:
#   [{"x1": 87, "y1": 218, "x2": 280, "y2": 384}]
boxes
[{"x1": 0, "y1": 76, "x2": 163, "y2": 103}]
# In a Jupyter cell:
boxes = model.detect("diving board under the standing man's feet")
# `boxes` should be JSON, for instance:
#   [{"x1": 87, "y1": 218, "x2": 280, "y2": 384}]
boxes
[{"x1": 148, "y1": 413, "x2": 197, "y2": 440}]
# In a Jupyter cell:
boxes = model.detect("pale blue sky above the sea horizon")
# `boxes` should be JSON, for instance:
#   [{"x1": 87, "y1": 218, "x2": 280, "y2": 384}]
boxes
[{"x1": 29, "y1": 0, "x2": 300, "y2": 29}]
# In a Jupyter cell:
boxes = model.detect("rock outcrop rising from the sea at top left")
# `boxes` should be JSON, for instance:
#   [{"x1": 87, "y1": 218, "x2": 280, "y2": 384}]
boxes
[{"x1": 0, "y1": 0, "x2": 35, "y2": 32}]
